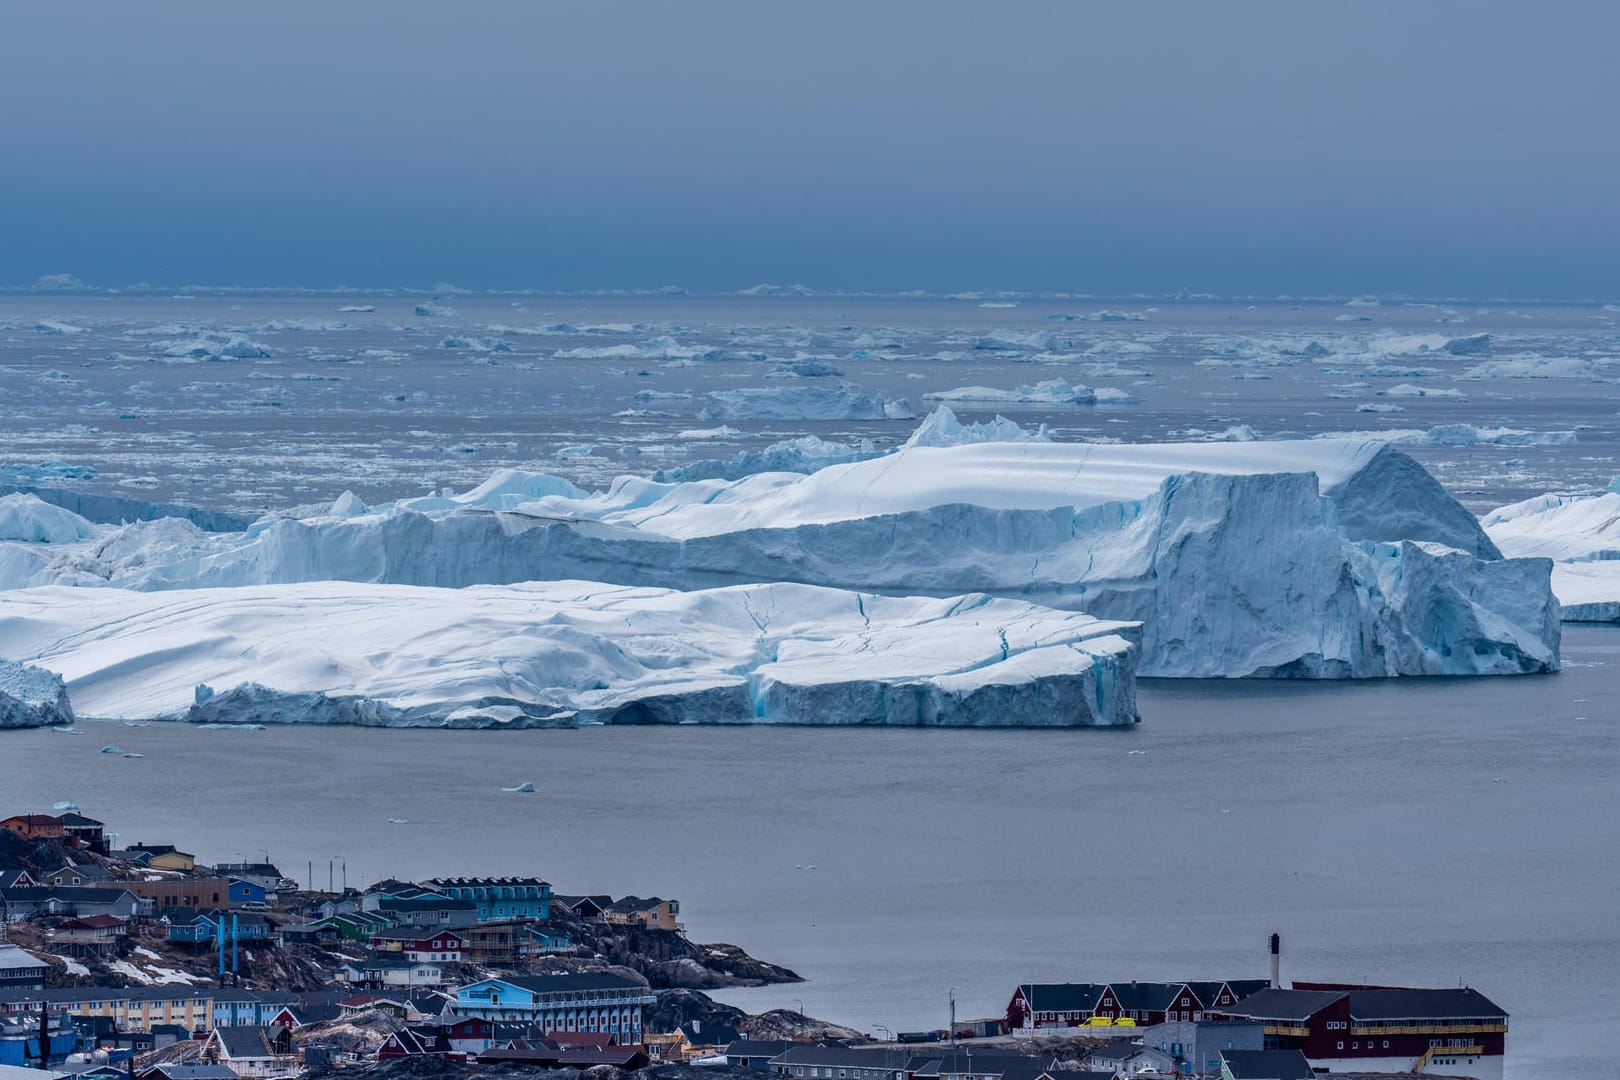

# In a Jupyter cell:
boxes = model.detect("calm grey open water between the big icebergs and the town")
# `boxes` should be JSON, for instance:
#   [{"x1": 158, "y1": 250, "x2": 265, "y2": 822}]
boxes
[{"x1": 0, "y1": 628, "x2": 1620, "y2": 1080}]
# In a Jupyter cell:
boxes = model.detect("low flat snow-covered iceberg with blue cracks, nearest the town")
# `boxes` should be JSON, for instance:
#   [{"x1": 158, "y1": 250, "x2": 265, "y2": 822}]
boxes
[{"x1": 0, "y1": 581, "x2": 1136, "y2": 727}]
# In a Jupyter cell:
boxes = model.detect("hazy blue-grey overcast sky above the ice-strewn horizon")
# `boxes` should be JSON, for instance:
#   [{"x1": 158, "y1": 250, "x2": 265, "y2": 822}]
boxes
[{"x1": 0, "y1": 0, "x2": 1620, "y2": 300}]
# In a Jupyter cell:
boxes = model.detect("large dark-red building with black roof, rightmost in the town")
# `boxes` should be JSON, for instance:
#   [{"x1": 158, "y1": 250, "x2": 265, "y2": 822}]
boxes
[{"x1": 1213, "y1": 983, "x2": 1508, "y2": 1080}]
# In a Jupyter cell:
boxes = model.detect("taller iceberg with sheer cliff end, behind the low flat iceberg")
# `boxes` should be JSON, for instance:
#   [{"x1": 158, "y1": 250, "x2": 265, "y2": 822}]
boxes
[{"x1": 28, "y1": 440, "x2": 1558, "y2": 677}]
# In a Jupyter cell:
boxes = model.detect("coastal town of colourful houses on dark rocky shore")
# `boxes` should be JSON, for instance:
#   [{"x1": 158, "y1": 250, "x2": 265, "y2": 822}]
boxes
[{"x1": 0, "y1": 805, "x2": 1508, "y2": 1080}]
